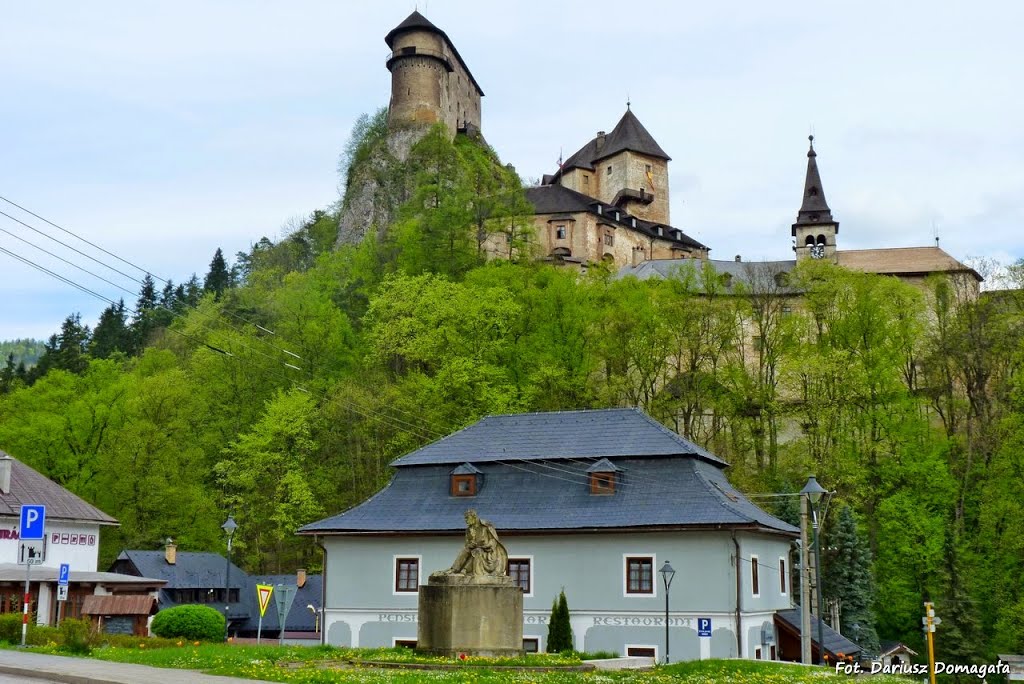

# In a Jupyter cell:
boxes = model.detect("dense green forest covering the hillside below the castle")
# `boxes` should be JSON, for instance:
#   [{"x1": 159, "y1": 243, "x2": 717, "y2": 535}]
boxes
[{"x1": 0, "y1": 116, "x2": 1024, "y2": 660}]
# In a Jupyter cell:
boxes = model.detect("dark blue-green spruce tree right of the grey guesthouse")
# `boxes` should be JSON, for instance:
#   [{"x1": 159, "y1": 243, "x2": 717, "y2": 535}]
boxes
[{"x1": 824, "y1": 506, "x2": 879, "y2": 653}]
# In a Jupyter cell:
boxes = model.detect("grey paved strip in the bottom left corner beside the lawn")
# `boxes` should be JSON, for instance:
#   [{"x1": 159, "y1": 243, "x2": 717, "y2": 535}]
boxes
[{"x1": 0, "y1": 649, "x2": 278, "y2": 684}]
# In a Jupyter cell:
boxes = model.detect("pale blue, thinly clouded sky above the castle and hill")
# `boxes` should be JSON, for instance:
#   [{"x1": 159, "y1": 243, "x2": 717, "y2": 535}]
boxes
[{"x1": 0, "y1": 0, "x2": 1024, "y2": 339}]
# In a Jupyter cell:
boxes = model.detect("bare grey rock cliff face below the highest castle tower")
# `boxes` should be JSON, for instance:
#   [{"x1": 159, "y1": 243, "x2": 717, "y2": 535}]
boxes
[{"x1": 337, "y1": 127, "x2": 429, "y2": 246}]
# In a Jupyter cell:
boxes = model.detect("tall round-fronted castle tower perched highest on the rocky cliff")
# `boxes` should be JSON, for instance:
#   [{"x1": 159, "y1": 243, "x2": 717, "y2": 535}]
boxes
[{"x1": 384, "y1": 11, "x2": 483, "y2": 135}]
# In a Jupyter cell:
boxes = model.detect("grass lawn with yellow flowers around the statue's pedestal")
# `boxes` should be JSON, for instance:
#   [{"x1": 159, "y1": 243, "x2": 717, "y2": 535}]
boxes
[{"x1": 16, "y1": 642, "x2": 908, "y2": 684}]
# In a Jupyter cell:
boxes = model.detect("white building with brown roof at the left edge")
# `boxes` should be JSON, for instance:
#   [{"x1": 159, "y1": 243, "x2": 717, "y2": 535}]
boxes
[{"x1": 0, "y1": 452, "x2": 163, "y2": 633}]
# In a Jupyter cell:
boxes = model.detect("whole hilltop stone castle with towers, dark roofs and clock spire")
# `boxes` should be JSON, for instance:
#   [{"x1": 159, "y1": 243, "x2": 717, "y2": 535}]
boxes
[{"x1": 384, "y1": 11, "x2": 981, "y2": 291}]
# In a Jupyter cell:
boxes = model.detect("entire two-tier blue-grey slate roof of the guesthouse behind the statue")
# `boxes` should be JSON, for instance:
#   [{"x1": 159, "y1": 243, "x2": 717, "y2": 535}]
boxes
[{"x1": 299, "y1": 410, "x2": 798, "y2": 537}]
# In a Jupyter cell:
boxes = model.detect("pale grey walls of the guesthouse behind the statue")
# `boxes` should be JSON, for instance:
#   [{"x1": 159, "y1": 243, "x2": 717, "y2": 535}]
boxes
[{"x1": 324, "y1": 528, "x2": 791, "y2": 660}]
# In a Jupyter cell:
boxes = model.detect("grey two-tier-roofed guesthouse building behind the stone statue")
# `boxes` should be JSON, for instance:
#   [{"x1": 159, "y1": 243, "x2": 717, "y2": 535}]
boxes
[{"x1": 299, "y1": 409, "x2": 798, "y2": 659}]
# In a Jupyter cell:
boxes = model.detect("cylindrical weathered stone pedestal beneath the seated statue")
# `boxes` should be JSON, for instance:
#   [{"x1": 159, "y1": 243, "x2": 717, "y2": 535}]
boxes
[{"x1": 416, "y1": 574, "x2": 522, "y2": 655}]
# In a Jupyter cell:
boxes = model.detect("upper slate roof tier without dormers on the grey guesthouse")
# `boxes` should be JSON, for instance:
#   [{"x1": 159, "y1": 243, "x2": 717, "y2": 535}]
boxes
[{"x1": 391, "y1": 409, "x2": 728, "y2": 468}]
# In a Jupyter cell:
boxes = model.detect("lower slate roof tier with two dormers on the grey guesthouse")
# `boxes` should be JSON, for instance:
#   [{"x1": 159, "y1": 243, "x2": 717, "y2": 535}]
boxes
[{"x1": 299, "y1": 456, "x2": 798, "y2": 537}]
